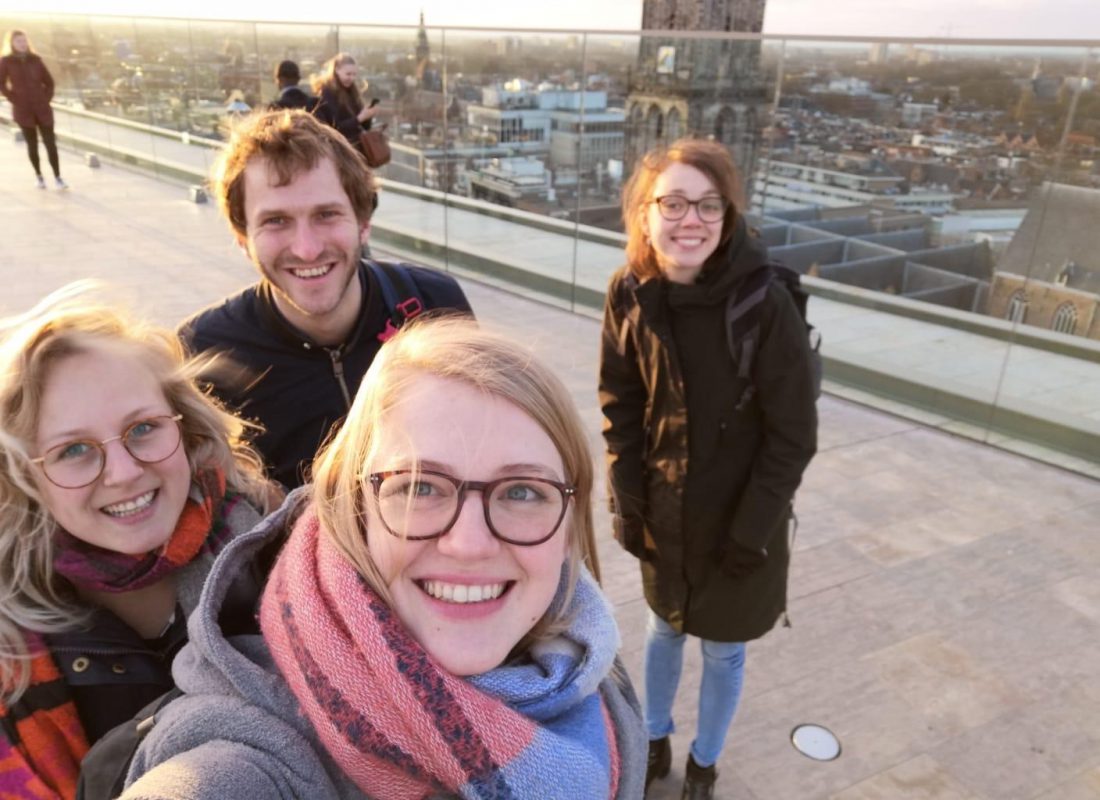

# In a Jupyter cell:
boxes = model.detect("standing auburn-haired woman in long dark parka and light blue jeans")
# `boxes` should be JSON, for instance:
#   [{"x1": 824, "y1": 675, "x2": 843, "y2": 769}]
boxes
[{"x1": 600, "y1": 140, "x2": 817, "y2": 800}]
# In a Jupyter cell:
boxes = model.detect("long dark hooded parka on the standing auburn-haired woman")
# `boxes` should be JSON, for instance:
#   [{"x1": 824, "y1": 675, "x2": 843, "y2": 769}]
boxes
[{"x1": 600, "y1": 220, "x2": 817, "y2": 642}]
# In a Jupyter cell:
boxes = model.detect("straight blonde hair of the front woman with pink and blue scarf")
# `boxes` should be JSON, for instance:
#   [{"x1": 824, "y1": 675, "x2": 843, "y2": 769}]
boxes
[{"x1": 314, "y1": 316, "x2": 600, "y2": 650}]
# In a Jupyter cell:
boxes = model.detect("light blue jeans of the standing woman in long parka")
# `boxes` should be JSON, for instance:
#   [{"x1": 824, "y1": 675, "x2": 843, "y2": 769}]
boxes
[{"x1": 646, "y1": 610, "x2": 745, "y2": 767}]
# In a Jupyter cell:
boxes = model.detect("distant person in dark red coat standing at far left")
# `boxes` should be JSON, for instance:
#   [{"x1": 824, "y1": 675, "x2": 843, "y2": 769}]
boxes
[{"x1": 0, "y1": 31, "x2": 68, "y2": 189}]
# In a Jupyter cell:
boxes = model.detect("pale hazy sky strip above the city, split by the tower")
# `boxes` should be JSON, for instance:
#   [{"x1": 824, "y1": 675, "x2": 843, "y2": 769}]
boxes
[{"x1": 13, "y1": 0, "x2": 1100, "y2": 40}]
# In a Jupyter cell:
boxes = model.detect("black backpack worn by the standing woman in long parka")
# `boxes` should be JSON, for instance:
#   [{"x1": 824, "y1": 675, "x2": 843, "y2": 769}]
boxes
[{"x1": 726, "y1": 262, "x2": 822, "y2": 410}]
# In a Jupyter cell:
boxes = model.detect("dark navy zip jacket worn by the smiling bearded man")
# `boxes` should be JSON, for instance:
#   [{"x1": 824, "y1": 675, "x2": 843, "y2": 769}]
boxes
[{"x1": 179, "y1": 259, "x2": 472, "y2": 489}]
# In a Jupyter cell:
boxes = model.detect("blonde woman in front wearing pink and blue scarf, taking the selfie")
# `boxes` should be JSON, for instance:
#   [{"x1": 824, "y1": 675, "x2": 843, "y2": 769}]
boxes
[{"x1": 123, "y1": 319, "x2": 646, "y2": 800}]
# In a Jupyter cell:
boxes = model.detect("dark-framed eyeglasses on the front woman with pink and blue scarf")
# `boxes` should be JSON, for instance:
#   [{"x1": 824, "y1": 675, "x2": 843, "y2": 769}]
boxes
[{"x1": 369, "y1": 470, "x2": 576, "y2": 547}]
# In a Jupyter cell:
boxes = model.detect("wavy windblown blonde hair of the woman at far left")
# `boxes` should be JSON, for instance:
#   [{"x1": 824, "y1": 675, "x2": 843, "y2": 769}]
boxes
[{"x1": 0, "y1": 281, "x2": 272, "y2": 699}]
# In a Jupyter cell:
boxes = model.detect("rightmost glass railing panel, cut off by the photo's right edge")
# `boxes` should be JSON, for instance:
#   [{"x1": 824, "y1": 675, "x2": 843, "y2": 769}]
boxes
[{"x1": 988, "y1": 47, "x2": 1100, "y2": 471}]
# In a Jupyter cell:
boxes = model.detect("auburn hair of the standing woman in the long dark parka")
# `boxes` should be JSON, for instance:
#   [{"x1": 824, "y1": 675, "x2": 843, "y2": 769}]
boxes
[{"x1": 623, "y1": 139, "x2": 741, "y2": 281}]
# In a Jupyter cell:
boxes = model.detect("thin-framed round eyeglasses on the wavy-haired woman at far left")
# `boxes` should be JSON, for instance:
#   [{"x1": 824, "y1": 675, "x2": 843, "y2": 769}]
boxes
[{"x1": 31, "y1": 414, "x2": 184, "y2": 489}]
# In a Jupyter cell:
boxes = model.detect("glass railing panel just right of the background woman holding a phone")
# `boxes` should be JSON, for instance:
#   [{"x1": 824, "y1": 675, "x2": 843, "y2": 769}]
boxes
[{"x1": 339, "y1": 25, "x2": 455, "y2": 277}]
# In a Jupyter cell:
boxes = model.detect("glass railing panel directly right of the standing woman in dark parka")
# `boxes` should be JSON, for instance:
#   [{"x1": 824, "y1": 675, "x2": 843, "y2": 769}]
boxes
[{"x1": 754, "y1": 41, "x2": 1042, "y2": 451}]
